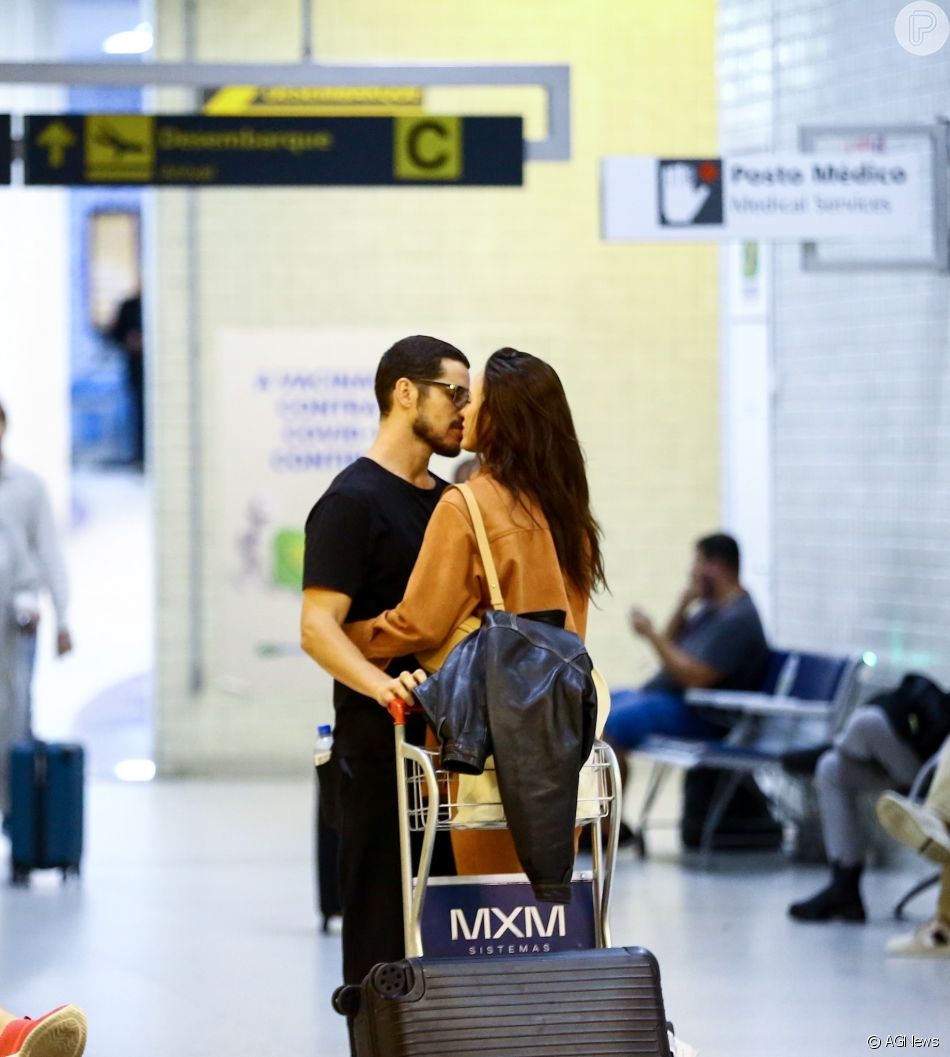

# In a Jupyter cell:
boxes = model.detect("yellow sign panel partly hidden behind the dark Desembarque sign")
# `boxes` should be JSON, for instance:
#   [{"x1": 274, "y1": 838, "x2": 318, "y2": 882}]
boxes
[{"x1": 202, "y1": 85, "x2": 423, "y2": 117}]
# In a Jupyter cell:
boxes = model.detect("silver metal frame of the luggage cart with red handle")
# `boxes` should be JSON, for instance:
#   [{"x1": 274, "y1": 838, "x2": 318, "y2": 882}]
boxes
[{"x1": 389, "y1": 701, "x2": 621, "y2": 958}]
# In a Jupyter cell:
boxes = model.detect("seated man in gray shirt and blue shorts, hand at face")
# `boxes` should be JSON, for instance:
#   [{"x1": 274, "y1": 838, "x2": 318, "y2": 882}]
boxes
[{"x1": 606, "y1": 533, "x2": 769, "y2": 756}]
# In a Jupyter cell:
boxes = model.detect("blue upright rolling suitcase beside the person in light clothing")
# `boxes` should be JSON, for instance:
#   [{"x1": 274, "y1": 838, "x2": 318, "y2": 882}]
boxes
[{"x1": 10, "y1": 741, "x2": 85, "y2": 885}]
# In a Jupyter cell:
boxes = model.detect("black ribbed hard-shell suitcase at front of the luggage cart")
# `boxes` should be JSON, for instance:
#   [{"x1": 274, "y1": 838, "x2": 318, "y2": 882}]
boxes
[{"x1": 334, "y1": 947, "x2": 670, "y2": 1057}]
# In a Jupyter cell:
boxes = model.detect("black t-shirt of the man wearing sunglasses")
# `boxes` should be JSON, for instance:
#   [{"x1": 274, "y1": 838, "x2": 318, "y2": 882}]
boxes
[{"x1": 303, "y1": 458, "x2": 446, "y2": 756}]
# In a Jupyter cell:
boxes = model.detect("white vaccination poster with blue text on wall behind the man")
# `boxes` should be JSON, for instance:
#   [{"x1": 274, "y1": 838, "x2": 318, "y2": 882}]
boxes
[{"x1": 203, "y1": 328, "x2": 393, "y2": 709}]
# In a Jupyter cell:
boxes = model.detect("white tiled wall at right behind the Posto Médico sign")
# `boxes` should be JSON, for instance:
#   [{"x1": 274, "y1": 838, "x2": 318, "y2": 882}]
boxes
[{"x1": 718, "y1": 0, "x2": 950, "y2": 680}]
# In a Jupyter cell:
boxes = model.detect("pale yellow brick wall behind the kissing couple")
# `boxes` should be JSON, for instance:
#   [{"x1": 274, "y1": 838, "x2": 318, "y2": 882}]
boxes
[{"x1": 153, "y1": 0, "x2": 719, "y2": 772}]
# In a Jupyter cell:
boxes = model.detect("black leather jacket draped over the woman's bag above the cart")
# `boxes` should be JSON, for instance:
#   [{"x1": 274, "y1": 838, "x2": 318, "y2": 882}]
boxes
[{"x1": 415, "y1": 610, "x2": 597, "y2": 903}]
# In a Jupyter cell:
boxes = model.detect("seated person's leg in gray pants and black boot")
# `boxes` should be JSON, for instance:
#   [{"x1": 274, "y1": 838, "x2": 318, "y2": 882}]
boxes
[{"x1": 788, "y1": 705, "x2": 920, "y2": 922}]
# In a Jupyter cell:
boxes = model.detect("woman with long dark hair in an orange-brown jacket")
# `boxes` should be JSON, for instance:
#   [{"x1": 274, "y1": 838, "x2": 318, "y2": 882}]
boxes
[{"x1": 346, "y1": 349, "x2": 604, "y2": 873}]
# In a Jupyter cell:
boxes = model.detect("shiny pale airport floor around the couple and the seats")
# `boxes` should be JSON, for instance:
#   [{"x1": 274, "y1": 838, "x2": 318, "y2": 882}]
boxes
[{"x1": 0, "y1": 782, "x2": 950, "y2": 1057}]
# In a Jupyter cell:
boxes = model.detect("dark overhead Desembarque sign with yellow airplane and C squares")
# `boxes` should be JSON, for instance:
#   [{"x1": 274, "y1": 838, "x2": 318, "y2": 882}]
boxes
[{"x1": 23, "y1": 114, "x2": 524, "y2": 187}]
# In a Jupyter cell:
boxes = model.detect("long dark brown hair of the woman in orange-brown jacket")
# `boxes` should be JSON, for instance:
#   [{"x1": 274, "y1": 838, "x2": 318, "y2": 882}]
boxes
[{"x1": 477, "y1": 349, "x2": 607, "y2": 592}]
